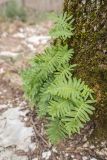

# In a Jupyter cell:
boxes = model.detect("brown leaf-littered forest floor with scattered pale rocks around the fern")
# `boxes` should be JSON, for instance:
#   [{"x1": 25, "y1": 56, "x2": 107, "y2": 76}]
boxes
[{"x1": 0, "y1": 21, "x2": 107, "y2": 160}]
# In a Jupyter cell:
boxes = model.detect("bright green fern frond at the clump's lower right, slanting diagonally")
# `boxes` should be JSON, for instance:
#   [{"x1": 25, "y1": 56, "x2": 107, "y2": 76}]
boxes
[{"x1": 63, "y1": 99, "x2": 94, "y2": 135}]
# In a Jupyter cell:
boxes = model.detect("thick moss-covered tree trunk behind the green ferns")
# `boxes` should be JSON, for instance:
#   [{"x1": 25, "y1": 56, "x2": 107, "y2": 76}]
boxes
[{"x1": 64, "y1": 0, "x2": 107, "y2": 139}]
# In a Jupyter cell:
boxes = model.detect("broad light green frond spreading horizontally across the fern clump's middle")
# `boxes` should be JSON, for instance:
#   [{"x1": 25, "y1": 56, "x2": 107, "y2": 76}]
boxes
[{"x1": 47, "y1": 78, "x2": 88, "y2": 101}]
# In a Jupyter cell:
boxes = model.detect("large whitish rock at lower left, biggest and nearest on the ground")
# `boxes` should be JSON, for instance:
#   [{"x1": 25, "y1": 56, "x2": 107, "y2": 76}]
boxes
[{"x1": 0, "y1": 107, "x2": 36, "y2": 152}]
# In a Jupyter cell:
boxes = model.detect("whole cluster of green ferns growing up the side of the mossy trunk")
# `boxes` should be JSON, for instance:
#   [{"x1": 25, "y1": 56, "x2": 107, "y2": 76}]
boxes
[{"x1": 22, "y1": 13, "x2": 95, "y2": 143}]
